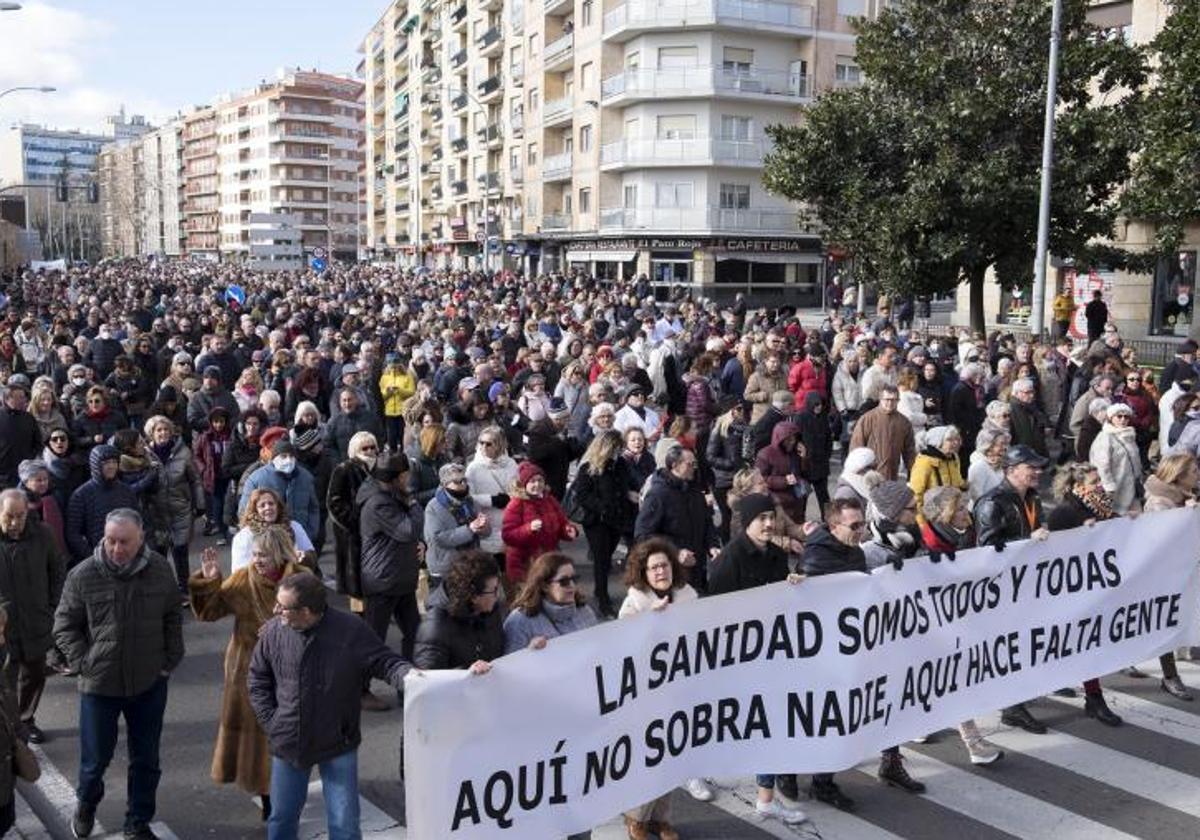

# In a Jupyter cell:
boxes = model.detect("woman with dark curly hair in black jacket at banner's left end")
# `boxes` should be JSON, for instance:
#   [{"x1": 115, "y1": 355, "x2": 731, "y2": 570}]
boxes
[{"x1": 413, "y1": 551, "x2": 504, "y2": 673}]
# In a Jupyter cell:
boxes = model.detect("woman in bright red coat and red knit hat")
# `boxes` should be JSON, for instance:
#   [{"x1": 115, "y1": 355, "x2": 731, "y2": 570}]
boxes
[{"x1": 500, "y1": 461, "x2": 578, "y2": 583}]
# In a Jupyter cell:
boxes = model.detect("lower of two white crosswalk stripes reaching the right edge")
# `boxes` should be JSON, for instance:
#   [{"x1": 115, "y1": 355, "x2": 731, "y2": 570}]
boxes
[{"x1": 976, "y1": 714, "x2": 1200, "y2": 817}]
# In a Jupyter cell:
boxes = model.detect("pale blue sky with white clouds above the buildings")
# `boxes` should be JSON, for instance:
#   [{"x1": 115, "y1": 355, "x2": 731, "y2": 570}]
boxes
[{"x1": 0, "y1": 0, "x2": 388, "y2": 131}]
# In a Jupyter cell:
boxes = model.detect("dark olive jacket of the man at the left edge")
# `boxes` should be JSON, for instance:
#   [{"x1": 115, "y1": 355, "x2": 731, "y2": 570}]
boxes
[{"x1": 0, "y1": 516, "x2": 66, "y2": 661}]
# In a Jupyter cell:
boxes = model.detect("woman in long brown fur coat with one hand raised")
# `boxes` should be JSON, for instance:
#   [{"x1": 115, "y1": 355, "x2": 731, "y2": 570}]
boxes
[{"x1": 187, "y1": 528, "x2": 307, "y2": 820}]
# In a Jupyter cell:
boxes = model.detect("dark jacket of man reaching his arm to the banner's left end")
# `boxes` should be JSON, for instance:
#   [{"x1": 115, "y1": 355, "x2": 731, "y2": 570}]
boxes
[{"x1": 246, "y1": 607, "x2": 412, "y2": 768}]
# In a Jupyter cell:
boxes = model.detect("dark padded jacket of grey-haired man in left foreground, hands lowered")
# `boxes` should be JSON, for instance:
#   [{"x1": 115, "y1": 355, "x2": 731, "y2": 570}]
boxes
[{"x1": 54, "y1": 545, "x2": 184, "y2": 697}]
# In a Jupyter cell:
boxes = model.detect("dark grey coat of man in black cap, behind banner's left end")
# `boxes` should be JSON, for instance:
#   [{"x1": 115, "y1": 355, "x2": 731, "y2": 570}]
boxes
[{"x1": 356, "y1": 478, "x2": 425, "y2": 595}]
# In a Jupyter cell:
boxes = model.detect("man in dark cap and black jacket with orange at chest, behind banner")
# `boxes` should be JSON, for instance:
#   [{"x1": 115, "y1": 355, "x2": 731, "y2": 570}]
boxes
[{"x1": 976, "y1": 445, "x2": 1050, "y2": 734}]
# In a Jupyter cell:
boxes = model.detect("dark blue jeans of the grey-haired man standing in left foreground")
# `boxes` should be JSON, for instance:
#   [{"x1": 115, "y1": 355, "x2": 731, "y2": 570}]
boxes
[{"x1": 76, "y1": 677, "x2": 167, "y2": 830}]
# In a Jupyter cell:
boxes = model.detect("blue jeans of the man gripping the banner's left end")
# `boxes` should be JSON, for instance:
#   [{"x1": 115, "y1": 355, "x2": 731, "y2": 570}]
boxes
[{"x1": 266, "y1": 750, "x2": 362, "y2": 840}]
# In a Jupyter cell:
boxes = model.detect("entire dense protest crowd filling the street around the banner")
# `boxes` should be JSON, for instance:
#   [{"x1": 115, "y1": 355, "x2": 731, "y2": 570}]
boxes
[{"x1": 0, "y1": 260, "x2": 1200, "y2": 840}]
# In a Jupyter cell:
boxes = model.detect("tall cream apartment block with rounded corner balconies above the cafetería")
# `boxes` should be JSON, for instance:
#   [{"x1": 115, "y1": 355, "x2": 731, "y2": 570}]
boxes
[{"x1": 359, "y1": 0, "x2": 868, "y2": 301}]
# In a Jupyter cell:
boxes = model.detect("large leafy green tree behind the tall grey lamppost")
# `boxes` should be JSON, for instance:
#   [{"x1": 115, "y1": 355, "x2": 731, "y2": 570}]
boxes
[{"x1": 763, "y1": 0, "x2": 1145, "y2": 330}]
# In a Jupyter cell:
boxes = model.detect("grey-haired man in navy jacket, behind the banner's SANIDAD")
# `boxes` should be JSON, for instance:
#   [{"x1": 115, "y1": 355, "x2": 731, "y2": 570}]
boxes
[{"x1": 634, "y1": 444, "x2": 720, "y2": 592}]
